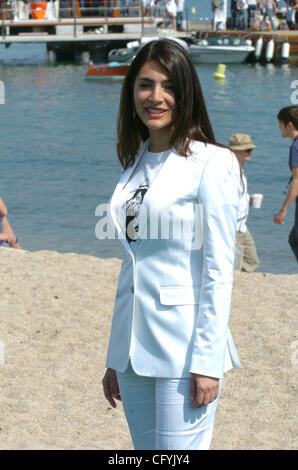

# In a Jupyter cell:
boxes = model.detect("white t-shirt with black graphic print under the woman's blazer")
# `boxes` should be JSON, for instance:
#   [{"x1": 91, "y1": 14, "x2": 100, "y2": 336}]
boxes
[{"x1": 120, "y1": 150, "x2": 170, "y2": 250}]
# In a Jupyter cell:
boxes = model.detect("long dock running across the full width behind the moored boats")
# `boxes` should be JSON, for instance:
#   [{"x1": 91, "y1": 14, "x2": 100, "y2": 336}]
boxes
[{"x1": 0, "y1": 8, "x2": 298, "y2": 65}]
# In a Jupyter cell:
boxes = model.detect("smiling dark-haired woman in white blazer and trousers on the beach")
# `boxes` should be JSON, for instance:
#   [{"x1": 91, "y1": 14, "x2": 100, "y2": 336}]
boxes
[{"x1": 103, "y1": 40, "x2": 241, "y2": 449}]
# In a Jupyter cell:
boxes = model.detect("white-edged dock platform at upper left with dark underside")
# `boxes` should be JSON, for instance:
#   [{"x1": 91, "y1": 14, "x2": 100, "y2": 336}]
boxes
[{"x1": 0, "y1": 13, "x2": 191, "y2": 62}]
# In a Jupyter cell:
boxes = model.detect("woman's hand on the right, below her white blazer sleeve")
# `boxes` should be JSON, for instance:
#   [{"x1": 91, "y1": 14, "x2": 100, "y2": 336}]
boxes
[{"x1": 190, "y1": 373, "x2": 219, "y2": 408}]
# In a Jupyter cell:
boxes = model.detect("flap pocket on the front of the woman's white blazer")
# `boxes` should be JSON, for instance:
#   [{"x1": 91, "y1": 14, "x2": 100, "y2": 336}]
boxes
[{"x1": 160, "y1": 285, "x2": 200, "y2": 305}]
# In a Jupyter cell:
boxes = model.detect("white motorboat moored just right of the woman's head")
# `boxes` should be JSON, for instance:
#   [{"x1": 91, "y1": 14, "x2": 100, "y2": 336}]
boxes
[{"x1": 188, "y1": 36, "x2": 255, "y2": 64}]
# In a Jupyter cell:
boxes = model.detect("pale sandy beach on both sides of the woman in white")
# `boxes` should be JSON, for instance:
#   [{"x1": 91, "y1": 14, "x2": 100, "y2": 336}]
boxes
[{"x1": 0, "y1": 248, "x2": 298, "y2": 450}]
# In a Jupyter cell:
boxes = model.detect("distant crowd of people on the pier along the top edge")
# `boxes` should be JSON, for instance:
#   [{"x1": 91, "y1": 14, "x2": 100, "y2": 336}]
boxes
[{"x1": 5, "y1": 0, "x2": 298, "y2": 31}]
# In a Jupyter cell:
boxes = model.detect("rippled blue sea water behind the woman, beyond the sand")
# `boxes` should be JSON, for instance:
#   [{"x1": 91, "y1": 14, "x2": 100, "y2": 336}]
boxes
[{"x1": 0, "y1": 2, "x2": 298, "y2": 273}]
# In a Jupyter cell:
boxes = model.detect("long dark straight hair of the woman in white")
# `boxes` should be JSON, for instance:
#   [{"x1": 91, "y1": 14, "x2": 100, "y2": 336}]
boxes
[{"x1": 117, "y1": 39, "x2": 223, "y2": 169}]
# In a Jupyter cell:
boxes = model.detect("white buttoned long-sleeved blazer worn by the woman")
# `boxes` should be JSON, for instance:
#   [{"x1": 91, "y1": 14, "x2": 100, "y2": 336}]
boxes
[{"x1": 106, "y1": 141, "x2": 241, "y2": 378}]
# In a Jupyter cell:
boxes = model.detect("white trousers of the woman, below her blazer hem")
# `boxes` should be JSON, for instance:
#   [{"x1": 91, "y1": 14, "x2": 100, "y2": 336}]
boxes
[{"x1": 117, "y1": 363, "x2": 222, "y2": 450}]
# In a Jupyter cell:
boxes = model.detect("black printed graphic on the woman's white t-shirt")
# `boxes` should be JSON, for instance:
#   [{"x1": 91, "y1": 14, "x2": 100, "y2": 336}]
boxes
[{"x1": 123, "y1": 178, "x2": 149, "y2": 243}]
